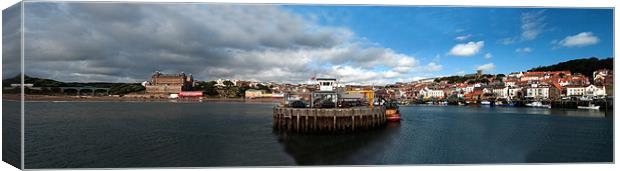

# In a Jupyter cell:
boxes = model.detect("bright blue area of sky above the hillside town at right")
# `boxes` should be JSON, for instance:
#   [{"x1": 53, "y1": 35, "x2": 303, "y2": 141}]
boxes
[{"x1": 286, "y1": 6, "x2": 613, "y2": 75}]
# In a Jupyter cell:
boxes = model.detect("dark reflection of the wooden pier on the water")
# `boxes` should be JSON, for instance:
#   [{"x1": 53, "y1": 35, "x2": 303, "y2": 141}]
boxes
[{"x1": 274, "y1": 123, "x2": 400, "y2": 165}]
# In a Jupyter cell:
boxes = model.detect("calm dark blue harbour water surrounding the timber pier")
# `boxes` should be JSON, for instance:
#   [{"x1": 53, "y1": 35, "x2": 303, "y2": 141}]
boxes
[{"x1": 15, "y1": 102, "x2": 613, "y2": 168}]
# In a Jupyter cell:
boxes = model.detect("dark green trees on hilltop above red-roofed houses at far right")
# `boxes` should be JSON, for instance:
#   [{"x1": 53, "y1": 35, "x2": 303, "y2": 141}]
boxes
[{"x1": 528, "y1": 57, "x2": 614, "y2": 81}]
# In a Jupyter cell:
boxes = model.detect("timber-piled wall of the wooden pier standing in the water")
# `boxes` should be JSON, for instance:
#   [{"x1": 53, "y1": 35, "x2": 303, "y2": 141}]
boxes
[{"x1": 273, "y1": 107, "x2": 387, "y2": 133}]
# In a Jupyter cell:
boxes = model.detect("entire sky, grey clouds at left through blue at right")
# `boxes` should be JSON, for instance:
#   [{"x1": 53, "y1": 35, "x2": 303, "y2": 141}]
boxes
[{"x1": 3, "y1": 2, "x2": 613, "y2": 85}]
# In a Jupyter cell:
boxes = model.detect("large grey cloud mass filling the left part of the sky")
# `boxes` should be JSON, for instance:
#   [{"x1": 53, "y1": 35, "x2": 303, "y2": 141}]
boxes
[{"x1": 20, "y1": 3, "x2": 426, "y2": 82}]
